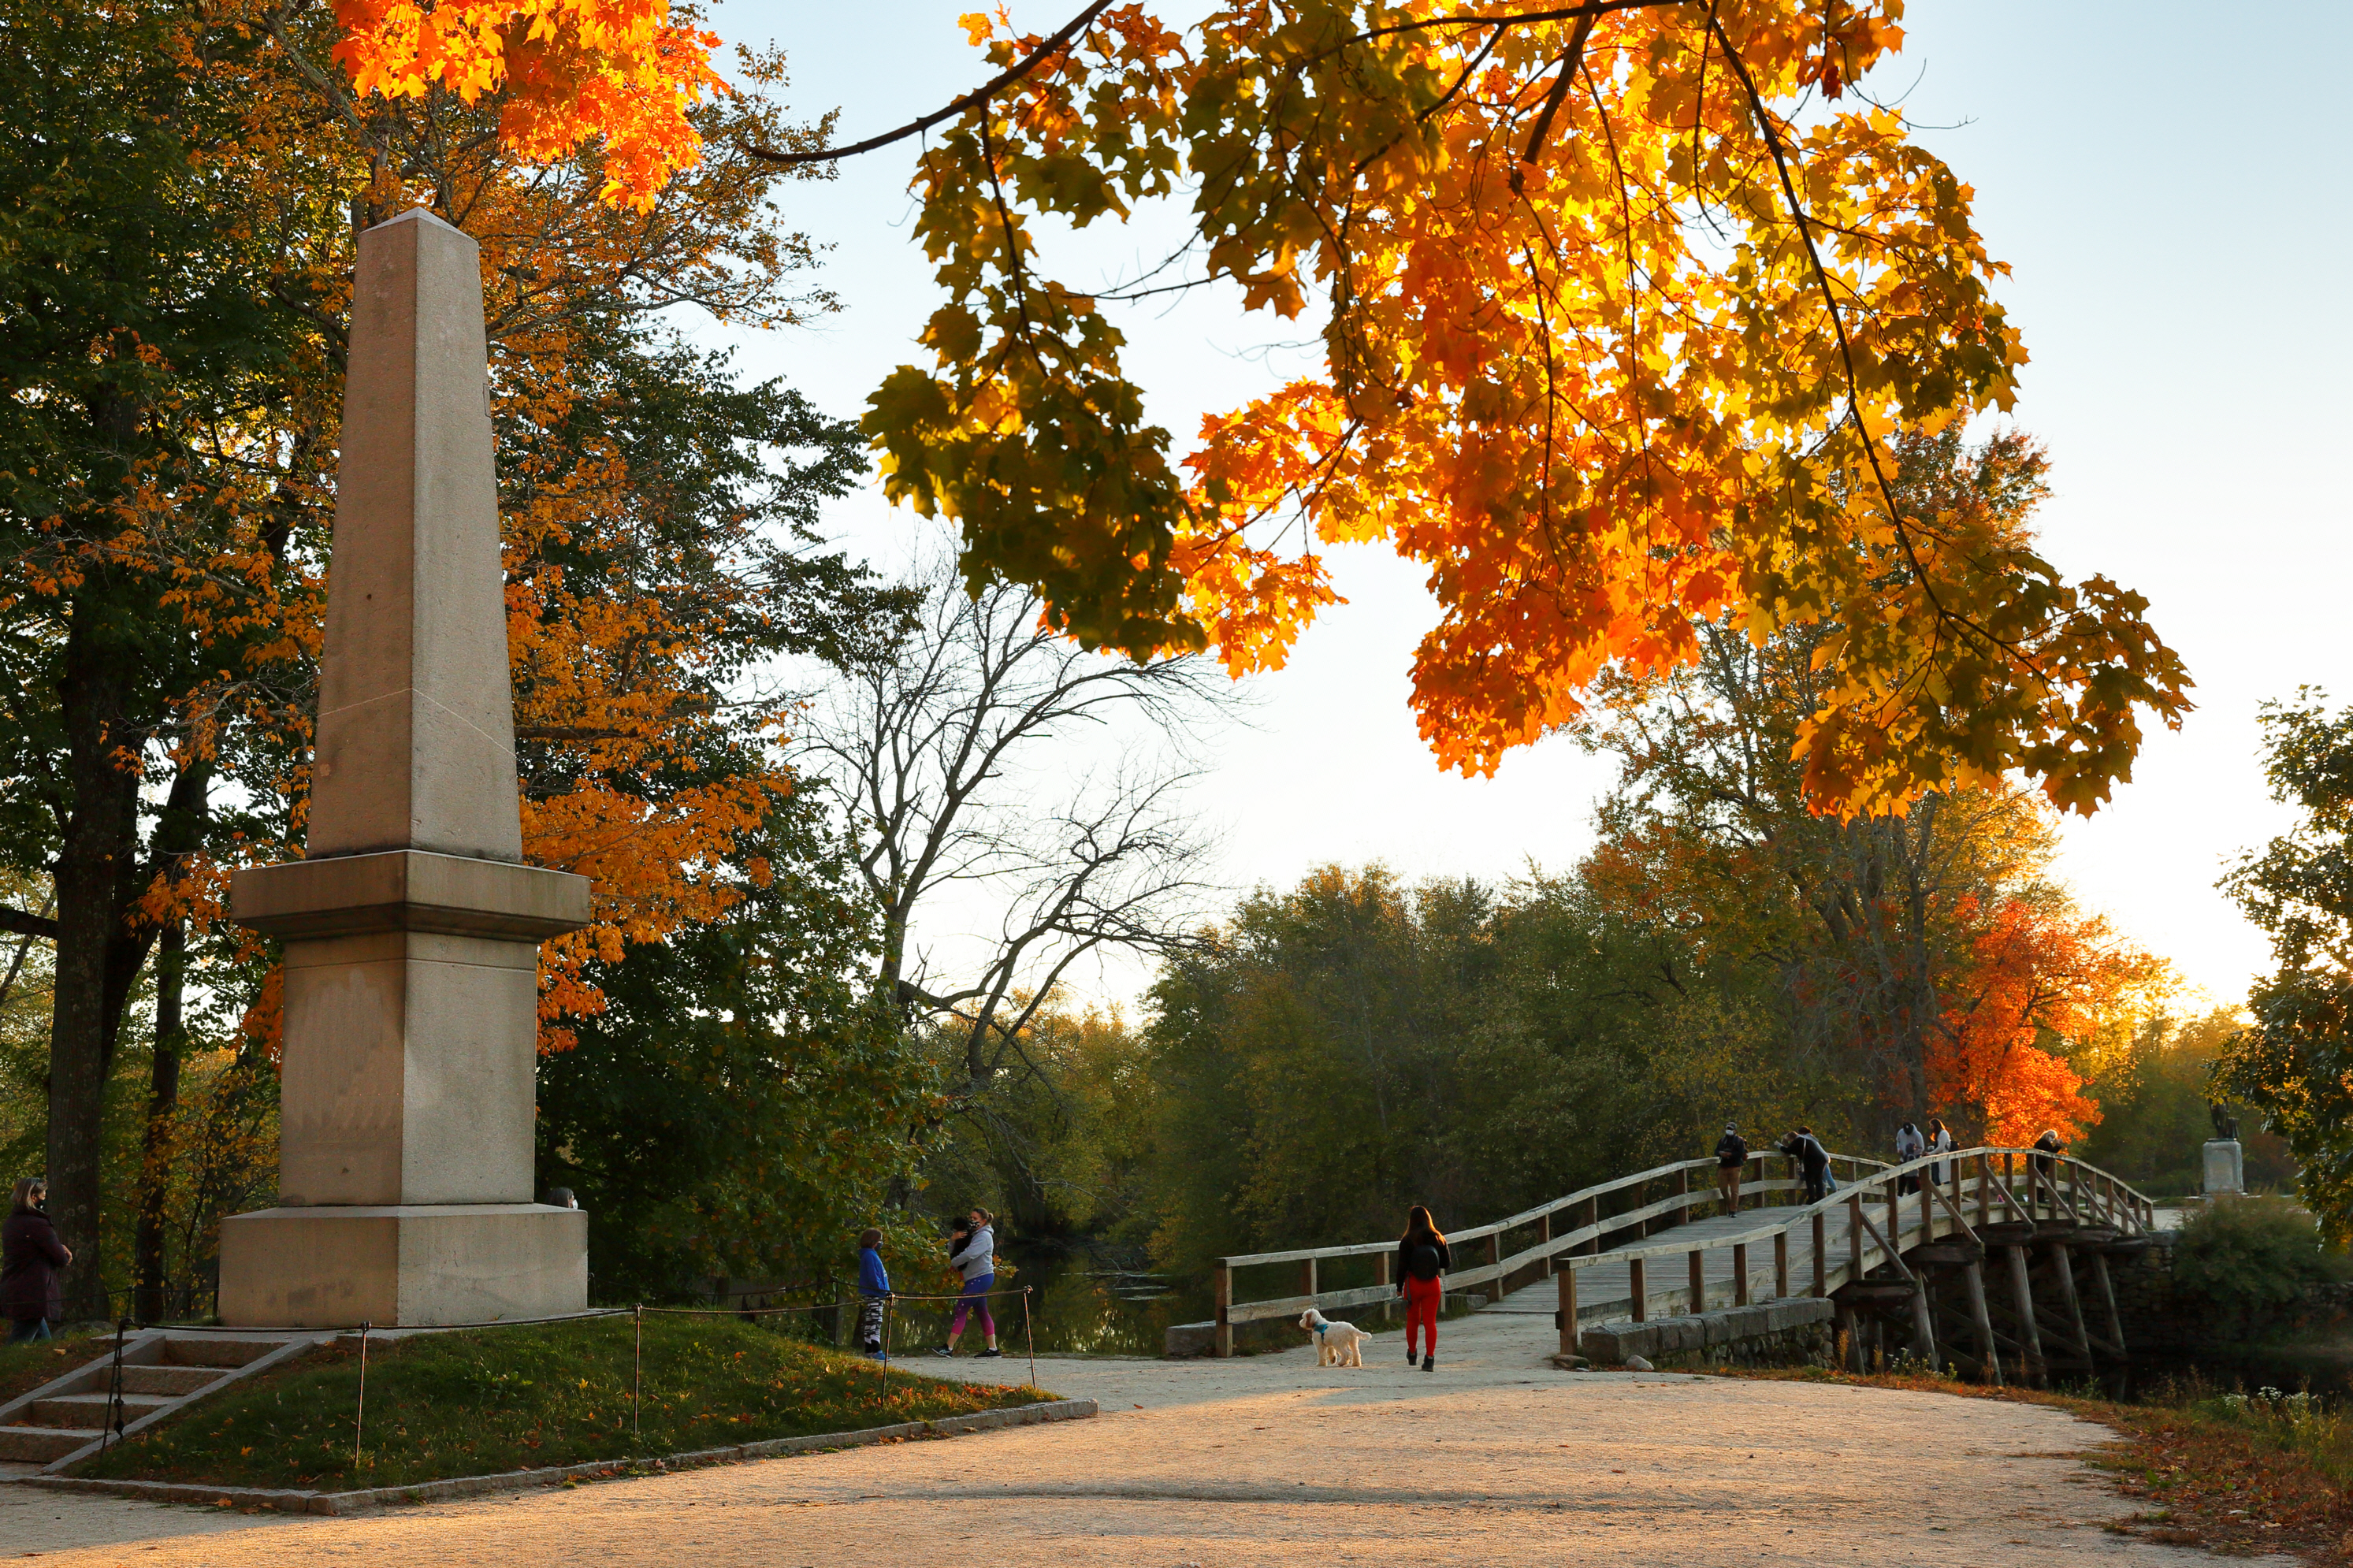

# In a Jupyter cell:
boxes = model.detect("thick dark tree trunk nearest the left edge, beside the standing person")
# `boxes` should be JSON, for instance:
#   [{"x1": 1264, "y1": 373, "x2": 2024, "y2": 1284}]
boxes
[{"x1": 47, "y1": 605, "x2": 146, "y2": 1321}]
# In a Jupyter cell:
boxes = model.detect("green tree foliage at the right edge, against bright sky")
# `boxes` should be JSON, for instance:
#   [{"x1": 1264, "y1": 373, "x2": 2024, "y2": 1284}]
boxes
[{"x1": 2214, "y1": 687, "x2": 2353, "y2": 1241}]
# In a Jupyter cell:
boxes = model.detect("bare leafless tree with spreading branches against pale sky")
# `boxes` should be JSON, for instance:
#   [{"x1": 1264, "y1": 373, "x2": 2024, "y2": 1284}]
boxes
[{"x1": 802, "y1": 560, "x2": 1231, "y2": 1097}]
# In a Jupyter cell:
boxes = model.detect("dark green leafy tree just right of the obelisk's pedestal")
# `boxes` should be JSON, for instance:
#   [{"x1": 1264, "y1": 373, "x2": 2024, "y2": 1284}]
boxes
[{"x1": 539, "y1": 798, "x2": 939, "y2": 1299}]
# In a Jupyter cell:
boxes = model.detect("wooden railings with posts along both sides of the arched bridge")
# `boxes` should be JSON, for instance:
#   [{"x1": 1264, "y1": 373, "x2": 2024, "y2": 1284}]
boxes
[{"x1": 1214, "y1": 1144, "x2": 2153, "y2": 1356}]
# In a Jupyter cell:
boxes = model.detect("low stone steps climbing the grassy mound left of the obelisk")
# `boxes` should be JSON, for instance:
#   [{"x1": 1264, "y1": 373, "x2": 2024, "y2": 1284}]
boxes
[{"x1": 0, "y1": 1328, "x2": 329, "y2": 1473}]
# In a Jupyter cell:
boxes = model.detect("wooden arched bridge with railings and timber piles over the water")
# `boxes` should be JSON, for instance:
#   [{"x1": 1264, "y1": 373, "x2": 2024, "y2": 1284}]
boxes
[{"x1": 1214, "y1": 1146, "x2": 2155, "y2": 1382}]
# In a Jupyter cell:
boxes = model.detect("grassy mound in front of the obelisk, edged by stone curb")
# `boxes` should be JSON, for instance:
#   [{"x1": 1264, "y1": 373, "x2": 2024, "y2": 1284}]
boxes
[{"x1": 73, "y1": 1316, "x2": 1052, "y2": 1490}]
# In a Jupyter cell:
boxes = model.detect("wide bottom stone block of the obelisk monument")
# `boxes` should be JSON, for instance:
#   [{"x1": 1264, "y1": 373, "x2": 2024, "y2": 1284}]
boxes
[{"x1": 221, "y1": 1203, "x2": 589, "y2": 1328}]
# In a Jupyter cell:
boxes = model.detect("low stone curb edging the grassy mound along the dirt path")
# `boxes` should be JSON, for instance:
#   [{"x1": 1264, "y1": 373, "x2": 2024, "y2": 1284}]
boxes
[{"x1": 17, "y1": 1399, "x2": 1098, "y2": 1514}]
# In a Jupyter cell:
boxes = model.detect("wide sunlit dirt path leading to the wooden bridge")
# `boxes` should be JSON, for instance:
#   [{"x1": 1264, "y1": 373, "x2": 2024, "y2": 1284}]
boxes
[{"x1": 0, "y1": 1313, "x2": 2212, "y2": 1568}]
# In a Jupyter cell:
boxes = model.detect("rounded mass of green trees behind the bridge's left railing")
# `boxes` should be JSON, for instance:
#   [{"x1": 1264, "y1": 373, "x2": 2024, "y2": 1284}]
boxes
[{"x1": 1146, "y1": 869, "x2": 1821, "y2": 1269}]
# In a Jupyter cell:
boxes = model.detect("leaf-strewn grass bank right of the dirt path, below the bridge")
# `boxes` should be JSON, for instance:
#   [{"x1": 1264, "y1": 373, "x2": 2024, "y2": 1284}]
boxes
[{"x1": 1694, "y1": 1368, "x2": 2353, "y2": 1568}]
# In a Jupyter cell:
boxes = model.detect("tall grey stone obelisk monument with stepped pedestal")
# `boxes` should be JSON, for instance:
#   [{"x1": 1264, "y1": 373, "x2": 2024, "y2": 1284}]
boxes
[{"x1": 221, "y1": 212, "x2": 589, "y2": 1325}]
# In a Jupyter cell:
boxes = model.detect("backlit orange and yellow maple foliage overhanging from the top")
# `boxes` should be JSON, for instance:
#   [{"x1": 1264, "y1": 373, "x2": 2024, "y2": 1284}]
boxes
[{"x1": 332, "y1": 0, "x2": 2188, "y2": 812}]
